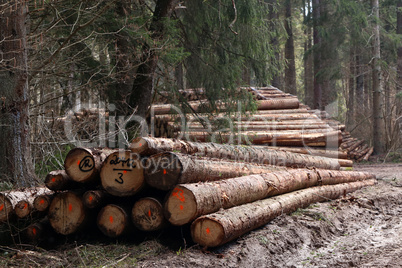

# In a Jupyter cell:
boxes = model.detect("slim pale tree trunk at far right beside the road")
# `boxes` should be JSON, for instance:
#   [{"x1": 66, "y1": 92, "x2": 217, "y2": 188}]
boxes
[{"x1": 371, "y1": 0, "x2": 385, "y2": 153}]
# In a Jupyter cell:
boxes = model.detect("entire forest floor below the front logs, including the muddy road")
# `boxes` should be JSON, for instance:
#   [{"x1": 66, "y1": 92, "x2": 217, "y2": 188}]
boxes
[{"x1": 0, "y1": 163, "x2": 402, "y2": 267}]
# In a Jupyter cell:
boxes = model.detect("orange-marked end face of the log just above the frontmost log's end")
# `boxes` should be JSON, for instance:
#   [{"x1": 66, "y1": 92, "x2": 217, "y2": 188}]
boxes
[{"x1": 164, "y1": 186, "x2": 197, "y2": 226}]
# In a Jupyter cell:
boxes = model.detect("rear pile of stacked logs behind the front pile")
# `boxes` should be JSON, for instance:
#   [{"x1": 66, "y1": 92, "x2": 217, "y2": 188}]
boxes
[{"x1": 151, "y1": 87, "x2": 372, "y2": 162}]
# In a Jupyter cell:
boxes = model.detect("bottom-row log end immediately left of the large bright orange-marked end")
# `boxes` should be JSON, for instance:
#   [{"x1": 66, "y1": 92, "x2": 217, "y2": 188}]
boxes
[{"x1": 131, "y1": 197, "x2": 166, "y2": 232}]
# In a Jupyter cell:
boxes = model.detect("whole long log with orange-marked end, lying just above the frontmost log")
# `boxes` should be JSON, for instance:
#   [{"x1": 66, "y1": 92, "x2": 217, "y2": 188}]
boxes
[{"x1": 164, "y1": 169, "x2": 375, "y2": 225}]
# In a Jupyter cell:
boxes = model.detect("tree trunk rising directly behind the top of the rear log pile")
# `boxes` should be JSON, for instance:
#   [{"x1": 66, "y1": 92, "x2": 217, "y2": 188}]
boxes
[{"x1": 284, "y1": 0, "x2": 297, "y2": 95}]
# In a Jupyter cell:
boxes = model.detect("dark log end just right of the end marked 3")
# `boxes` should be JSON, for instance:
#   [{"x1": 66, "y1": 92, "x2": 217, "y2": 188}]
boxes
[{"x1": 144, "y1": 153, "x2": 183, "y2": 191}]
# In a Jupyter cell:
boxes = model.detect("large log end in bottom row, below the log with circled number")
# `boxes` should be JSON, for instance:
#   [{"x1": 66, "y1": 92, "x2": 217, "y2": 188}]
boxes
[{"x1": 48, "y1": 192, "x2": 88, "y2": 235}]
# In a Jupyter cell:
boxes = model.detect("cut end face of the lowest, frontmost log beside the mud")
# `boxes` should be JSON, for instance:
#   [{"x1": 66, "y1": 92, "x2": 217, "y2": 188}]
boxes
[{"x1": 191, "y1": 217, "x2": 225, "y2": 247}]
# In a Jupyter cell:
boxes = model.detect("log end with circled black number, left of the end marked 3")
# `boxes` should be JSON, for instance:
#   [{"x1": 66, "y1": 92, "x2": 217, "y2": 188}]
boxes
[{"x1": 64, "y1": 148, "x2": 97, "y2": 183}]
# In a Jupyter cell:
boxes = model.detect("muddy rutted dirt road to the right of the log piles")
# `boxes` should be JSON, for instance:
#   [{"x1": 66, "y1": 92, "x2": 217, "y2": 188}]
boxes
[{"x1": 137, "y1": 164, "x2": 402, "y2": 267}]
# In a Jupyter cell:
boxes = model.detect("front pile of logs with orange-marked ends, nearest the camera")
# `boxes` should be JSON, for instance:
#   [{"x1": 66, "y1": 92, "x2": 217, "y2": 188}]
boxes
[{"x1": 0, "y1": 137, "x2": 376, "y2": 247}]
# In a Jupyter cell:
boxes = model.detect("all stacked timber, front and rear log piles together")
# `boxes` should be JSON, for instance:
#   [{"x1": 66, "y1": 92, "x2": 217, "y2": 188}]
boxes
[{"x1": 0, "y1": 87, "x2": 376, "y2": 247}]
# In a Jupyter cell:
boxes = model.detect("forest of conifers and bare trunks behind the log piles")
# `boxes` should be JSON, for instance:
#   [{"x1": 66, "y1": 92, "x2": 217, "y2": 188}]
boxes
[{"x1": 0, "y1": 0, "x2": 402, "y2": 188}]
